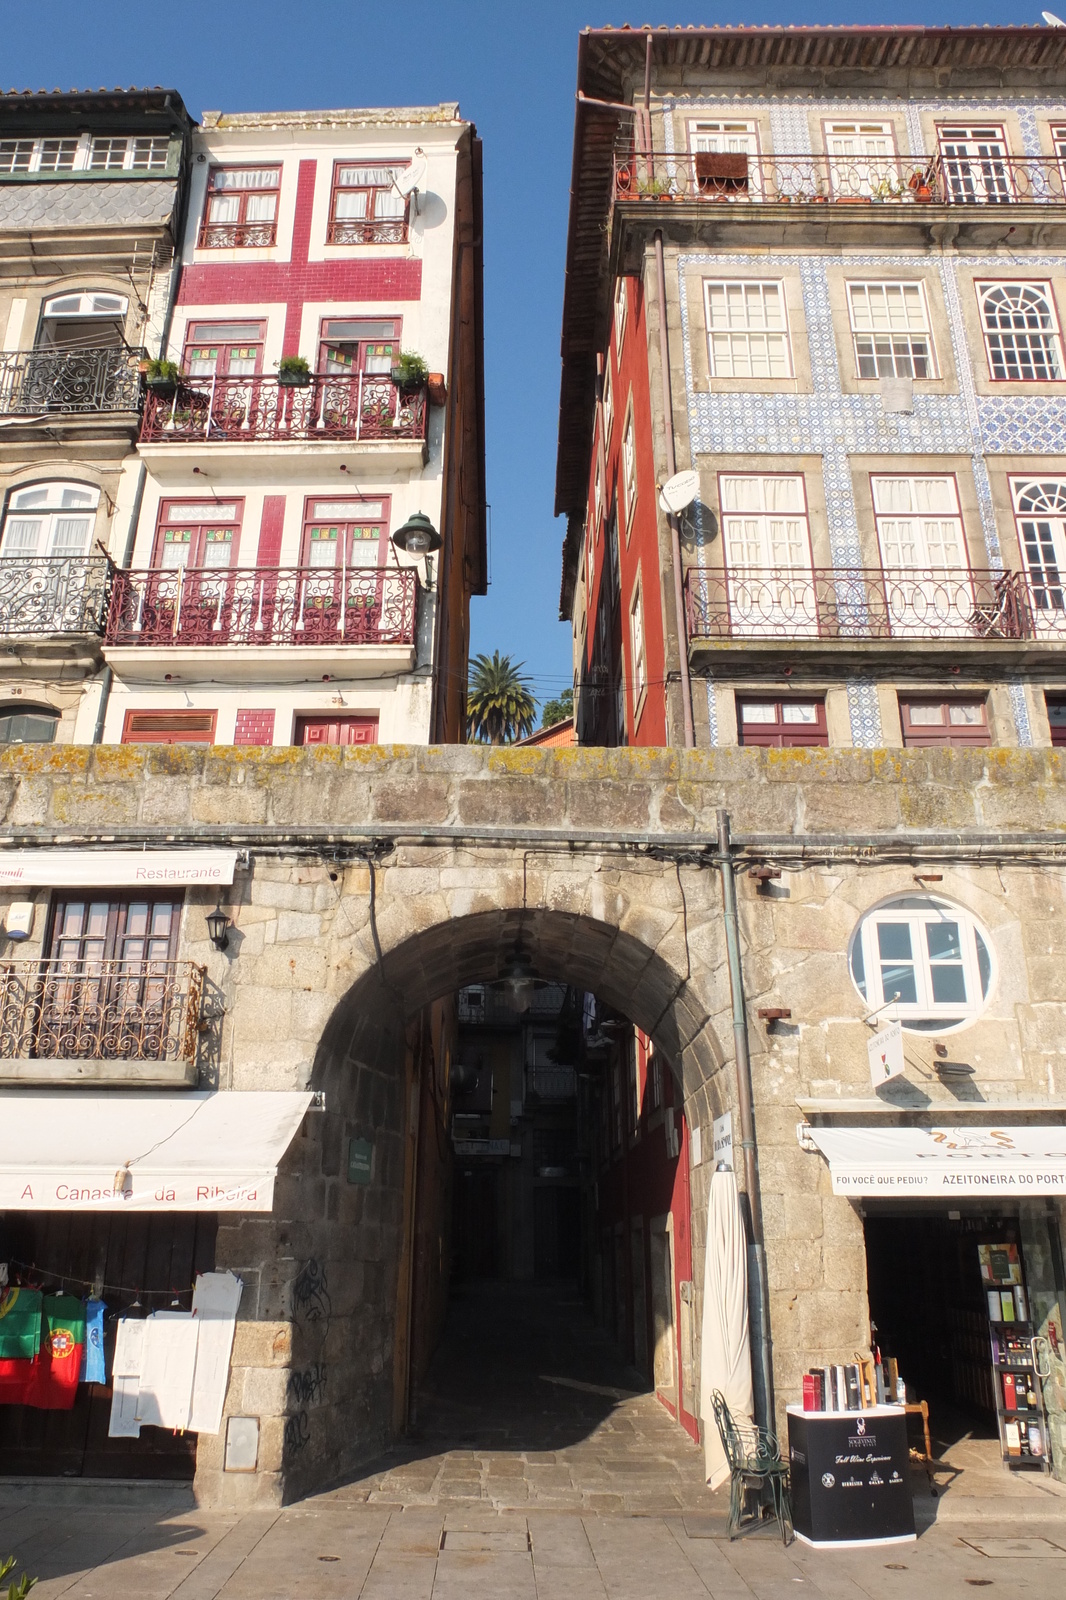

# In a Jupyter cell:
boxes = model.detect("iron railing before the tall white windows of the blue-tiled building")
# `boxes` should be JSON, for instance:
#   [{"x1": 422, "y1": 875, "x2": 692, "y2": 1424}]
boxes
[{"x1": 685, "y1": 566, "x2": 1066, "y2": 642}]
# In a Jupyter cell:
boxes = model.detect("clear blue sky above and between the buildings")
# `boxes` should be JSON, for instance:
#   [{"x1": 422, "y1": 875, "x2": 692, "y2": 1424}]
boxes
[{"x1": 0, "y1": 0, "x2": 1042, "y2": 713}]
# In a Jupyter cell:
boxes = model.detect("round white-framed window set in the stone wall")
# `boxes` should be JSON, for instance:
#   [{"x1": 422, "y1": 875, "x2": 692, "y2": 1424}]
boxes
[{"x1": 850, "y1": 894, "x2": 992, "y2": 1034}]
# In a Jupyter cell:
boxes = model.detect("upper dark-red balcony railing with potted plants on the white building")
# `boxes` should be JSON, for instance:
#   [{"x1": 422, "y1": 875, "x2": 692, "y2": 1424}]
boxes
[{"x1": 141, "y1": 373, "x2": 427, "y2": 443}]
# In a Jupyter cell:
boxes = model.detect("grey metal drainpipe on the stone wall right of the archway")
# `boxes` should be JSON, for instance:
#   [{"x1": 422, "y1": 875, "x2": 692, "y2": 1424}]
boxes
[{"x1": 715, "y1": 810, "x2": 773, "y2": 1429}]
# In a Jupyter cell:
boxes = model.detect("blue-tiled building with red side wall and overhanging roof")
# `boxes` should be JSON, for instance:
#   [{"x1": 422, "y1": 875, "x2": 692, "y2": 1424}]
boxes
[{"x1": 557, "y1": 20, "x2": 1066, "y2": 747}]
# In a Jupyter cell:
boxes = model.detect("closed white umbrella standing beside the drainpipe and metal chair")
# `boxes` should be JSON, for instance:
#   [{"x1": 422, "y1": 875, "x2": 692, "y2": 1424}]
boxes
[{"x1": 699, "y1": 1168, "x2": 754, "y2": 1490}]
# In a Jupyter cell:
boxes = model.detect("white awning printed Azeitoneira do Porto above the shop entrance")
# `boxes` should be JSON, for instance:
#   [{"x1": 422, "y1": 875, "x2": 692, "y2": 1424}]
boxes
[{"x1": 804, "y1": 1125, "x2": 1066, "y2": 1198}]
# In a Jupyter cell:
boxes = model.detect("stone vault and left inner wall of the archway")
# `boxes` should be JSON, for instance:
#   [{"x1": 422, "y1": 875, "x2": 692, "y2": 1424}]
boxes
[{"x1": 230, "y1": 896, "x2": 725, "y2": 1499}]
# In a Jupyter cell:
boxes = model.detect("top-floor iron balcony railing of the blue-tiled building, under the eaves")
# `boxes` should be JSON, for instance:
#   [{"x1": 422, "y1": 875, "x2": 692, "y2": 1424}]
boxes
[{"x1": 615, "y1": 152, "x2": 1066, "y2": 205}]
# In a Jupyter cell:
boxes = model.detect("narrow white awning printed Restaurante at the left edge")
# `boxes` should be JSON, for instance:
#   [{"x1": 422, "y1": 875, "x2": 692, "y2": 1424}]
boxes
[{"x1": 0, "y1": 850, "x2": 237, "y2": 890}]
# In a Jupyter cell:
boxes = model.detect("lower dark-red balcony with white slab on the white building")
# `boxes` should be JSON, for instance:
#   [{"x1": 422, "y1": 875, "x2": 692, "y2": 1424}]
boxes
[{"x1": 106, "y1": 566, "x2": 418, "y2": 680}]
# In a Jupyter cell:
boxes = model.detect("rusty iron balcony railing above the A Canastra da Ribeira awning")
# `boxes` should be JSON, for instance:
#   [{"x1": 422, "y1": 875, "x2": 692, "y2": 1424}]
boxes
[{"x1": 0, "y1": 960, "x2": 203, "y2": 1061}]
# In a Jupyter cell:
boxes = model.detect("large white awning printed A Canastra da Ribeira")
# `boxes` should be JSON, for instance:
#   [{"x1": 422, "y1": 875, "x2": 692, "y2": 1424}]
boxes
[{"x1": 0, "y1": 1090, "x2": 311, "y2": 1211}]
